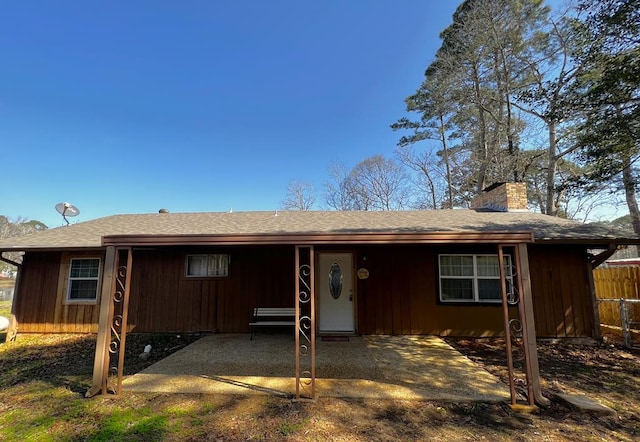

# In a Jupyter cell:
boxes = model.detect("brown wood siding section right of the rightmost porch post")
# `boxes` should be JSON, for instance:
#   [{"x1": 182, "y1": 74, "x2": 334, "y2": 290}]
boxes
[{"x1": 529, "y1": 245, "x2": 593, "y2": 338}]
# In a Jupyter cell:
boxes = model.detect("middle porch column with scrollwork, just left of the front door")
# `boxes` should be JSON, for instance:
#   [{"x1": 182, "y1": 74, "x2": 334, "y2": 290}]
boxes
[{"x1": 295, "y1": 246, "x2": 316, "y2": 401}]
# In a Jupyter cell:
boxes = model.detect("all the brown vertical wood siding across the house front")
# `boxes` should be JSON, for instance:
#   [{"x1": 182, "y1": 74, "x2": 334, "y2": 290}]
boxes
[{"x1": 16, "y1": 245, "x2": 593, "y2": 337}]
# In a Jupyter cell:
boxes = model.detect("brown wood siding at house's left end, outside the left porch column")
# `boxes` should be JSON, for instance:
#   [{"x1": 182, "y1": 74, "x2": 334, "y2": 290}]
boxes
[{"x1": 15, "y1": 252, "x2": 103, "y2": 333}]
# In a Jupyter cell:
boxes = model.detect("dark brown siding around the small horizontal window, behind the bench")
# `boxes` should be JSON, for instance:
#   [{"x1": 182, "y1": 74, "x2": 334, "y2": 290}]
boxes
[{"x1": 129, "y1": 246, "x2": 294, "y2": 333}]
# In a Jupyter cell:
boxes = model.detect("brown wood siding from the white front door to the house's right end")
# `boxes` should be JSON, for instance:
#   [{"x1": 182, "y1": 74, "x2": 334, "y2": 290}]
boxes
[{"x1": 356, "y1": 245, "x2": 594, "y2": 338}]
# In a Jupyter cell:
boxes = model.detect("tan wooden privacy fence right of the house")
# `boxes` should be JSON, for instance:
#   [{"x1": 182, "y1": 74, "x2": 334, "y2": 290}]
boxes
[{"x1": 593, "y1": 266, "x2": 640, "y2": 345}]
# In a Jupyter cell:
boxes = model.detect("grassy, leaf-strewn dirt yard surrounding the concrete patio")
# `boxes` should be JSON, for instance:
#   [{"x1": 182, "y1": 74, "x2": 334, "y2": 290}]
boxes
[{"x1": 0, "y1": 334, "x2": 640, "y2": 441}]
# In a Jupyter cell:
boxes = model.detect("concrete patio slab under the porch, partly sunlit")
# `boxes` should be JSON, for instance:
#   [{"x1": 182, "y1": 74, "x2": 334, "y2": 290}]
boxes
[{"x1": 123, "y1": 334, "x2": 509, "y2": 402}]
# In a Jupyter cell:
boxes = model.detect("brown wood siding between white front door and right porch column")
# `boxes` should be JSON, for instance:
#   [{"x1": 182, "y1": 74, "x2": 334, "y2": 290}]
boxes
[{"x1": 356, "y1": 246, "x2": 516, "y2": 336}]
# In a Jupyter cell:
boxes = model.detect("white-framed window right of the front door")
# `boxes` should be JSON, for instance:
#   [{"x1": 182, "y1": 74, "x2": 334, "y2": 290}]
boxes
[{"x1": 438, "y1": 255, "x2": 513, "y2": 303}]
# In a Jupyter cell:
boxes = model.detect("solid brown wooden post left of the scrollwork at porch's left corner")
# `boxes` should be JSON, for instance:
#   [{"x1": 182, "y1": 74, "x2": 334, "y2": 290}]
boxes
[{"x1": 85, "y1": 246, "x2": 117, "y2": 397}]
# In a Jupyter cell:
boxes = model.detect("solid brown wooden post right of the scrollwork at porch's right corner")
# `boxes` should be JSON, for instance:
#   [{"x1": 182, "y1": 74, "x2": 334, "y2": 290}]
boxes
[{"x1": 515, "y1": 243, "x2": 551, "y2": 406}]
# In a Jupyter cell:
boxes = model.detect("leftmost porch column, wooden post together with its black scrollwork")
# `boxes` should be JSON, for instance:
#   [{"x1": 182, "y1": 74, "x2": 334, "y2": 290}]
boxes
[{"x1": 85, "y1": 246, "x2": 133, "y2": 397}]
